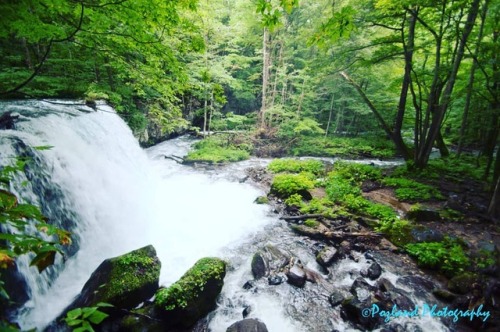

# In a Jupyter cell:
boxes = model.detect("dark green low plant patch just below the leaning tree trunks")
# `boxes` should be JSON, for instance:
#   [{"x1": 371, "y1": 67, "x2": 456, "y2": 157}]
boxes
[{"x1": 382, "y1": 177, "x2": 443, "y2": 201}]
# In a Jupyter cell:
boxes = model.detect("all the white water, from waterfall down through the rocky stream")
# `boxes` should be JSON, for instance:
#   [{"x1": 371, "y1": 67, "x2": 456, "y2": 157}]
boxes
[{"x1": 0, "y1": 101, "x2": 446, "y2": 332}]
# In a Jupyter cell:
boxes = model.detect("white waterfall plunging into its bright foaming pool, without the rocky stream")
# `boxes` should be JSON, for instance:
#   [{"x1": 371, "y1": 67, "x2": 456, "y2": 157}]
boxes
[{"x1": 0, "y1": 101, "x2": 278, "y2": 329}]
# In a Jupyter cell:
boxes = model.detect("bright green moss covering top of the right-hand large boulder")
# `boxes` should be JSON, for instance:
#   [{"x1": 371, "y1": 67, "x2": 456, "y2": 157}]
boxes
[{"x1": 155, "y1": 258, "x2": 226, "y2": 311}]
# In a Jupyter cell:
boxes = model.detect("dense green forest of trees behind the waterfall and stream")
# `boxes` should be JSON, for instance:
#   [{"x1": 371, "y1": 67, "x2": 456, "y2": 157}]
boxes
[{"x1": 0, "y1": 0, "x2": 500, "y2": 330}]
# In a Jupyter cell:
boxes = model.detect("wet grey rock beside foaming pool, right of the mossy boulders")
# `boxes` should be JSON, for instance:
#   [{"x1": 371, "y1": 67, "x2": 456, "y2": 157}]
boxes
[{"x1": 252, "y1": 245, "x2": 290, "y2": 279}]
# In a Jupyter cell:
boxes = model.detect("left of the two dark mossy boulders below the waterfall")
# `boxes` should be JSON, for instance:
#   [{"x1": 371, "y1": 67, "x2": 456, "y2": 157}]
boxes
[{"x1": 69, "y1": 245, "x2": 161, "y2": 309}]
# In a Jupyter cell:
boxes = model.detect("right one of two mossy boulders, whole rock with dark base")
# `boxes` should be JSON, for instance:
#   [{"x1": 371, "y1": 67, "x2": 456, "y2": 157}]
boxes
[{"x1": 155, "y1": 257, "x2": 226, "y2": 328}]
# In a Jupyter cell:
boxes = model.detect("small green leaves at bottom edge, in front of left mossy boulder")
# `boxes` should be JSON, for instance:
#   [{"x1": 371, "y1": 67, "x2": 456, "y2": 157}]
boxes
[{"x1": 63, "y1": 302, "x2": 112, "y2": 332}]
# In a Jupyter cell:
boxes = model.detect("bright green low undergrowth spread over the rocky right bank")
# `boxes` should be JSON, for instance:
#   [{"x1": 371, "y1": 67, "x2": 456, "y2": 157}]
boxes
[{"x1": 268, "y1": 159, "x2": 497, "y2": 278}]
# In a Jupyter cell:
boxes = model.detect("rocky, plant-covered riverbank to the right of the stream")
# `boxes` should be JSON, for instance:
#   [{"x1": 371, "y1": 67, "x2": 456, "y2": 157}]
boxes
[{"x1": 248, "y1": 161, "x2": 500, "y2": 331}]
